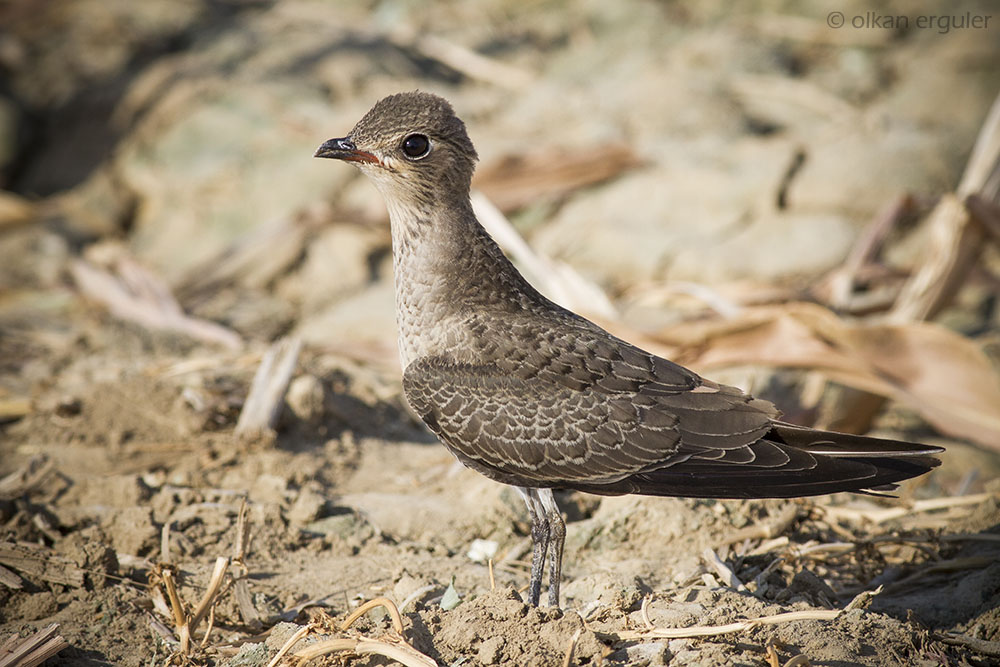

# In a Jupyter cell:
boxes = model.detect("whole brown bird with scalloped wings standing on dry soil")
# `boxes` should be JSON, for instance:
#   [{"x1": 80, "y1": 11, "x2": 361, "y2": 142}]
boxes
[{"x1": 314, "y1": 91, "x2": 944, "y2": 607}]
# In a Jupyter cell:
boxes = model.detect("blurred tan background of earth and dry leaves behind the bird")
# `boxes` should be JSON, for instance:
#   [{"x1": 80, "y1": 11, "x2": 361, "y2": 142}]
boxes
[{"x1": 0, "y1": 0, "x2": 1000, "y2": 664}]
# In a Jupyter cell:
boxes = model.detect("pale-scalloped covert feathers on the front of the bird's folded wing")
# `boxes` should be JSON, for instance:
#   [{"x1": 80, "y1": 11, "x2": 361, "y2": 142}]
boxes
[{"x1": 403, "y1": 358, "x2": 678, "y2": 486}]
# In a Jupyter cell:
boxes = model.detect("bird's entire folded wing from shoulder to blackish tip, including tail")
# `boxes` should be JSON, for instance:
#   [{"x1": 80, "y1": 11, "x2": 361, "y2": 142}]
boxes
[{"x1": 403, "y1": 313, "x2": 940, "y2": 498}]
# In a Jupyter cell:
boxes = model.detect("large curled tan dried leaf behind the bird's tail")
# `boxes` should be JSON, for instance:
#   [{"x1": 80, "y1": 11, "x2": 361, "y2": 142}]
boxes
[{"x1": 658, "y1": 303, "x2": 1000, "y2": 448}]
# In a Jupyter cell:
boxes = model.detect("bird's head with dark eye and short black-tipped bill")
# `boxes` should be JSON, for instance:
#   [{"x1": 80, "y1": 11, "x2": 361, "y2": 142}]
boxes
[{"x1": 315, "y1": 92, "x2": 477, "y2": 210}]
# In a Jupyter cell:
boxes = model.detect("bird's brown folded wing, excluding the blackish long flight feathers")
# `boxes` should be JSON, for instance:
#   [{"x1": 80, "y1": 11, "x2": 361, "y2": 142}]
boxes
[{"x1": 403, "y1": 353, "x2": 787, "y2": 486}]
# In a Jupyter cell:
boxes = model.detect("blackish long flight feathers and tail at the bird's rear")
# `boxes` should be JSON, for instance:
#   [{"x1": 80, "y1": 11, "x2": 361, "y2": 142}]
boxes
[{"x1": 572, "y1": 422, "x2": 944, "y2": 498}]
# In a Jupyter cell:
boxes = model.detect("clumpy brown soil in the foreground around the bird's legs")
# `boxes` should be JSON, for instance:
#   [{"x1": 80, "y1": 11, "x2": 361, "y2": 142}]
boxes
[{"x1": 0, "y1": 316, "x2": 1000, "y2": 665}]
